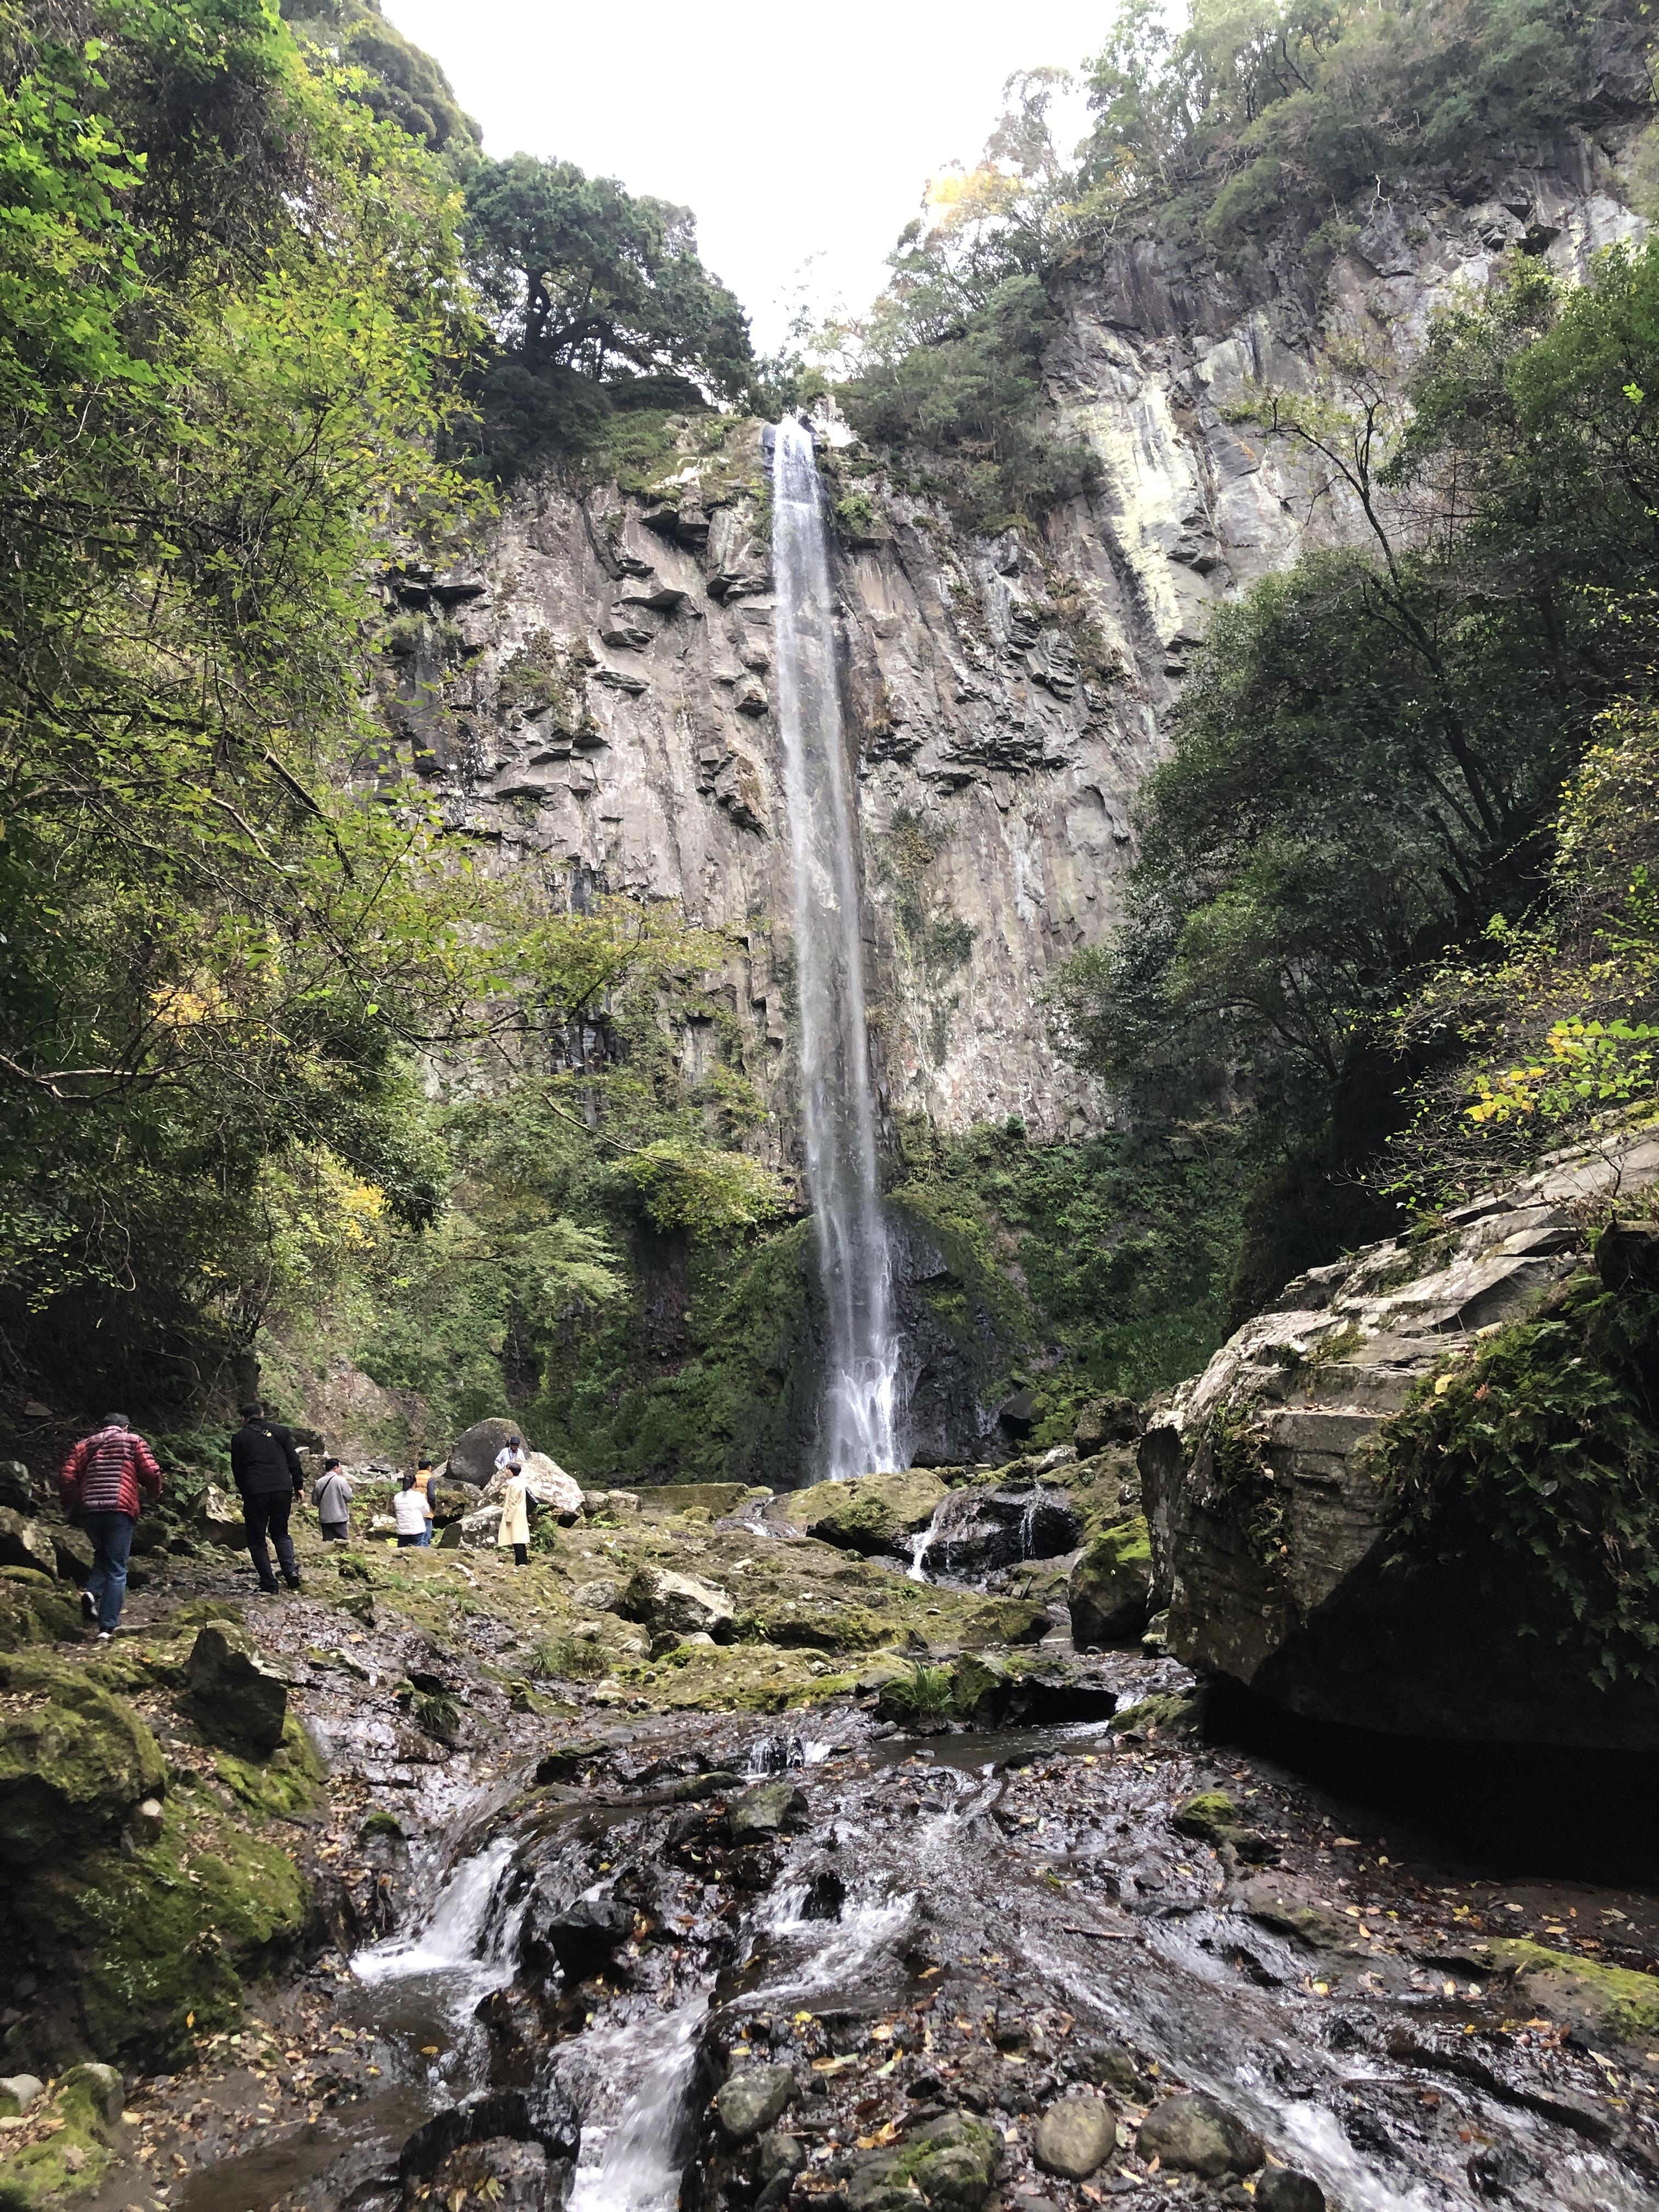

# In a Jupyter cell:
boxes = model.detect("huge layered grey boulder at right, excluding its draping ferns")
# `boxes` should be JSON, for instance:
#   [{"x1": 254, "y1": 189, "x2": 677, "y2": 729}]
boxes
[{"x1": 1139, "y1": 1130, "x2": 1659, "y2": 1752}]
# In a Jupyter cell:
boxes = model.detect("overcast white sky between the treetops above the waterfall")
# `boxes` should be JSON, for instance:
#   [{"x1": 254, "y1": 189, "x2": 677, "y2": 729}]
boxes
[{"x1": 383, "y1": 0, "x2": 1113, "y2": 352}]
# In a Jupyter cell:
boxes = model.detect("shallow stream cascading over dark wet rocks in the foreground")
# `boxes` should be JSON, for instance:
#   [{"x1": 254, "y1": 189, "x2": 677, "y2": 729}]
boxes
[{"x1": 175, "y1": 1652, "x2": 1659, "y2": 2212}]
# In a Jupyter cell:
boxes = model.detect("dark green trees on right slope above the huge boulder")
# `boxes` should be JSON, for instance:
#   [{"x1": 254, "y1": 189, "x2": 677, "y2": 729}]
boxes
[{"x1": 1055, "y1": 248, "x2": 1659, "y2": 1296}]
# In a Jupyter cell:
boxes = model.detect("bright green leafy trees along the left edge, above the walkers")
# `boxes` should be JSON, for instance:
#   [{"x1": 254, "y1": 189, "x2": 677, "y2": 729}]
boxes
[{"x1": 0, "y1": 0, "x2": 493, "y2": 1404}]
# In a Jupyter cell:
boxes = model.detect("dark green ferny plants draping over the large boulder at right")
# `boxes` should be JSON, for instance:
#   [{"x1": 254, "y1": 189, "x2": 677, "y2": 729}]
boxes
[{"x1": 1376, "y1": 1276, "x2": 1659, "y2": 1685}]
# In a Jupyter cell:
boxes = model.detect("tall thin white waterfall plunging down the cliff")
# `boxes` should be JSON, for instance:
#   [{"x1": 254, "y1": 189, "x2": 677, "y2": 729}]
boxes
[{"x1": 772, "y1": 416, "x2": 900, "y2": 1475}]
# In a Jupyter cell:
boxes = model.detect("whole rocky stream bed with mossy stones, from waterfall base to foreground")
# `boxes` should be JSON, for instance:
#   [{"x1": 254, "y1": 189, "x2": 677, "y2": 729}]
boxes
[{"x1": 0, "y1": 1451, "x2": 1659, "y2": 2212}]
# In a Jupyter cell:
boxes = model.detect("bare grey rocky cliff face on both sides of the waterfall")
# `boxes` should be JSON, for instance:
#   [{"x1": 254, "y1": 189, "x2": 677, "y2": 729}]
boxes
[{"x1": 390, "y1": 126, "x2": 1641, "y2": 1166}]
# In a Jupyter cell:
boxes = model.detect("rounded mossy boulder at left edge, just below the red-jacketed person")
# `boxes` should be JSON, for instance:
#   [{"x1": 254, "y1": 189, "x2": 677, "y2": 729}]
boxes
[{"x1": 0, "y1": 1652, "x2": 166, "y2": 1865}]
